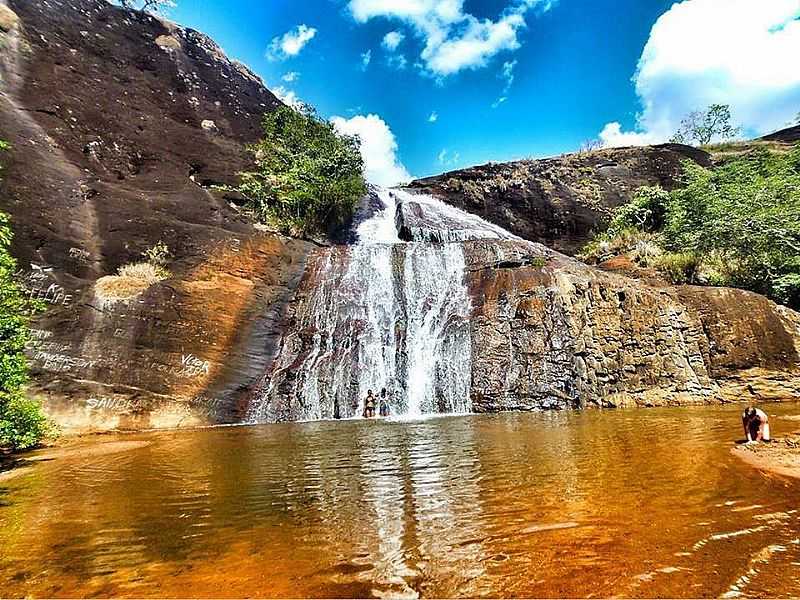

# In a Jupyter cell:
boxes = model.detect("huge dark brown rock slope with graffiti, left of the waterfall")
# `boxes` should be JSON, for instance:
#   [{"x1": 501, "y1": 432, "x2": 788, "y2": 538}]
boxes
[{"x1": 0, "y1": 0, "x2": 313, "y2": 430}]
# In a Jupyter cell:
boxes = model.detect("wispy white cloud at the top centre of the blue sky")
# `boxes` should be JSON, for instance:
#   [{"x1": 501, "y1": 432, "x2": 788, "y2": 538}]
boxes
[{"x1": 348, "y1": 0, "x2": 553, "y2": 77}]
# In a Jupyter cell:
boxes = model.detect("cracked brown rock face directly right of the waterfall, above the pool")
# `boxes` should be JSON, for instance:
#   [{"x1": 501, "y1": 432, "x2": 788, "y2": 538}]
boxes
[{"x1": 466, "y1": 242, "x2": 800, "y2": 411}]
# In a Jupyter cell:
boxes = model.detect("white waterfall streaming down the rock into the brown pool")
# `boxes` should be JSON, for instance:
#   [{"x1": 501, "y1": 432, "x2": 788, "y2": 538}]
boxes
[{"x1": 248, "y1": 188, "x2": 513, "y2": 422}]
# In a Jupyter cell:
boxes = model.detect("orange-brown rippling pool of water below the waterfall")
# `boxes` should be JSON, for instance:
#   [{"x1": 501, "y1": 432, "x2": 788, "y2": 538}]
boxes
[{"x1": 0, "y1": 405, "x2": 800, "y2": 597}]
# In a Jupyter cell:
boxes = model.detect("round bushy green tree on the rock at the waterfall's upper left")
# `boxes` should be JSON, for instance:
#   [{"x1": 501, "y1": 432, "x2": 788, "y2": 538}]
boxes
[{"x1": 237, "y1": 106, "x2": 367, "y2": 235}]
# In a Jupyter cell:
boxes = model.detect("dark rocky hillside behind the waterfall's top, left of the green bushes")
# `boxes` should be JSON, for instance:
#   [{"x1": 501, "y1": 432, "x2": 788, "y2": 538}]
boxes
[{"x1": 409, "y1": 144, "x2": 710, "y2": 255}]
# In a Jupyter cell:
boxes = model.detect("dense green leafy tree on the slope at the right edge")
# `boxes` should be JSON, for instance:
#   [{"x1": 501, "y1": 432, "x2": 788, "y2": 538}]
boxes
[{"x1": 663, "y1": 146, "x2": 800, "y2": 308}]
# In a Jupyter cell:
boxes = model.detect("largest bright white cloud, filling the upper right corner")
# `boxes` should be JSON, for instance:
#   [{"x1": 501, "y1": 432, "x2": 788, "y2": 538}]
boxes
[{"x1": 601, "y1": 0, "x2": 800, "y2": 145}]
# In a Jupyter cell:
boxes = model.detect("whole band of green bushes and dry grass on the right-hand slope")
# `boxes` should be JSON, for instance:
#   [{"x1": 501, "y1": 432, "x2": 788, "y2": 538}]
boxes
[{"x1": 583, "y1": 146, "x2": 800, "y2": 309}]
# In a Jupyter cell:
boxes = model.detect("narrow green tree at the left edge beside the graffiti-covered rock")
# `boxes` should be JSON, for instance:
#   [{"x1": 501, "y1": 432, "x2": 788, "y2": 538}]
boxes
[{"x1": 0, "y1": 142, "x2": 49, "y2": 449}]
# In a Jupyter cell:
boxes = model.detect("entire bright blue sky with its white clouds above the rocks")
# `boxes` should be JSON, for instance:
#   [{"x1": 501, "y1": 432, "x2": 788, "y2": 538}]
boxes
[{"x1": 169, "y1": 0, "x2": 800, "y2": 183}]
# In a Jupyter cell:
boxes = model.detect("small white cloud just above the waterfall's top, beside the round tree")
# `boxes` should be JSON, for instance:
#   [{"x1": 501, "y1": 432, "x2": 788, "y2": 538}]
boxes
[{"x1": 331, "y1": 114, "x2": 413, "y2": 186}]
